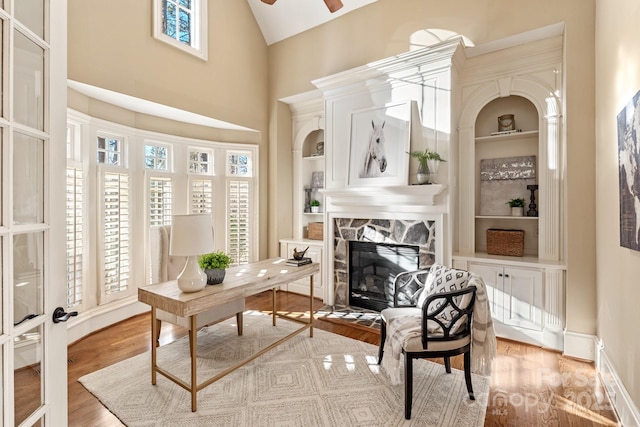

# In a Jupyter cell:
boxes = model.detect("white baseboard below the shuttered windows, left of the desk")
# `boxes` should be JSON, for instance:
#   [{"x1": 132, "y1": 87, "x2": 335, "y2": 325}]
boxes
[{"x1": 67, "y1": 295, "x2": 151, "y2": 344}]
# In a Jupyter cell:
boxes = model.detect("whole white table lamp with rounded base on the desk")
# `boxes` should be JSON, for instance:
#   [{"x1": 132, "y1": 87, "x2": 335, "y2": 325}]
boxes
[{"x1": 169, "y1": 214, "x2": 213, "y2": 292}]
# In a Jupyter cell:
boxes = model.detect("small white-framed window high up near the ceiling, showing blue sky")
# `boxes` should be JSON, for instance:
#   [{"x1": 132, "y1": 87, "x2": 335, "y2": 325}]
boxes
[{"x1": 153, "y1": 0, "x2": 207, "y2": 60}]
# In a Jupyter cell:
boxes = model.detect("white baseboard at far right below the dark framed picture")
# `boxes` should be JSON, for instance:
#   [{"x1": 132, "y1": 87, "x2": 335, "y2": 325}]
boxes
[{"x1": 596, "y1": 345, "x2": 640, "y2": 427}]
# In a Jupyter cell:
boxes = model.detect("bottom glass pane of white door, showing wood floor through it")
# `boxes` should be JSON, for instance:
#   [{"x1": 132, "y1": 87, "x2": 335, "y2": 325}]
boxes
[{"x1": 13, "y1": 325, "x2": 44, "y2": 425}]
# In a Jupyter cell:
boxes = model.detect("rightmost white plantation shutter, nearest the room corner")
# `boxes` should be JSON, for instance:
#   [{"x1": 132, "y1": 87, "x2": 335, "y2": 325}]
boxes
[{"x1": 227, "y1": 180, "x2": 251, "y2": 264}]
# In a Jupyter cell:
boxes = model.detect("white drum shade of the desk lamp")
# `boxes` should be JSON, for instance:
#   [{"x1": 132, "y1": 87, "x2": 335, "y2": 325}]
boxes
[{"x1": 169, "y1": 214, "x2": 213, "y2": 256}]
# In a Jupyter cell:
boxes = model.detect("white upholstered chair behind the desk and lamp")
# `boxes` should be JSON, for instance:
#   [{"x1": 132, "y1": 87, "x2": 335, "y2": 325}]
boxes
[{"x1": 149, "y1": 225, "x2": 244, "y2": 345}]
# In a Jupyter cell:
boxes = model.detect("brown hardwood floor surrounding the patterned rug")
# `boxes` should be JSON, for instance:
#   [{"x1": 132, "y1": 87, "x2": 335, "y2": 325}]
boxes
[{"x1": 68, "y1": 292, "x2": 618, "y2": 427}]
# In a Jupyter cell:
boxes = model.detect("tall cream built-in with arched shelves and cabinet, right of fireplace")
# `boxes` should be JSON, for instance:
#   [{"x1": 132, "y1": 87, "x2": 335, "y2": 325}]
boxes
[{"x1": 452, "y1": 38, "x2": 567, "y2": 350}]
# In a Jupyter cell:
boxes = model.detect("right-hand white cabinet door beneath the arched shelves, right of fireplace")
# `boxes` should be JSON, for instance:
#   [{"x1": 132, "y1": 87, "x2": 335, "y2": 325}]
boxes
[{"x1": 502, "y1": 268, "x2": 544, "y2": 331}]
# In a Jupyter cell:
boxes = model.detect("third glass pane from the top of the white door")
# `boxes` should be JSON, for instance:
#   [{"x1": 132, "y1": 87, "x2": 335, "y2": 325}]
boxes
[{"x1": 13, "y1": 132, "x2": 44, "y2": 224}]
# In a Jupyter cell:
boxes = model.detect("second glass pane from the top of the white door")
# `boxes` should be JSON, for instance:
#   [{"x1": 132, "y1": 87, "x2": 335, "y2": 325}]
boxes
[{"x1": 13, "y1": 31, "x2": 44, "y2": 130}]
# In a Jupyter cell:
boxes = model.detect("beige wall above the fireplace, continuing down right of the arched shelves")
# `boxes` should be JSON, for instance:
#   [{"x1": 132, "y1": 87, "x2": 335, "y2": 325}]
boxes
[{"x1": 269, "y1": 0, "x2": 596, "y2": 334}]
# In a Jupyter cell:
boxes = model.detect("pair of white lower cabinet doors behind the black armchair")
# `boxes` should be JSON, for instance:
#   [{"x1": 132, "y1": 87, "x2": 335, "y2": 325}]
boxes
[{"x1": 469, "y1": 262, "x2": 544, "y2": 331}]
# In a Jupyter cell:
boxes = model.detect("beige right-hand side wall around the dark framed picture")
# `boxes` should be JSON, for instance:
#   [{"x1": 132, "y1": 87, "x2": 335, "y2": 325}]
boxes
[{"x1": 595, "y1": 0, "x2": 640, "y2": 406}]
